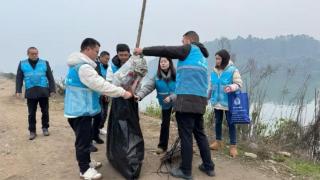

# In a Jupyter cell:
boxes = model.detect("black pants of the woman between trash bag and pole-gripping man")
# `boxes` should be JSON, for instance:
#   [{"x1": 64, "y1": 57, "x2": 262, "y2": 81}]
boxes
[{"x1": 158, "y1": 108, "x2": 172, "y2": 150}]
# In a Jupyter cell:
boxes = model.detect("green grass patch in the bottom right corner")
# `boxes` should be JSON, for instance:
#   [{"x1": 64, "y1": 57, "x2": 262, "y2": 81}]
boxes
[{"x1": 286, "y1": 159, "x2": 320, "y2": 179}]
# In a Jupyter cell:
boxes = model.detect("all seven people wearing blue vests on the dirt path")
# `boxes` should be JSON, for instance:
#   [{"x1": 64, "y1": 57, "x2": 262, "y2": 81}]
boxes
[{"x1": 16, "y1": 31, "x2": 242, "y2": 179}]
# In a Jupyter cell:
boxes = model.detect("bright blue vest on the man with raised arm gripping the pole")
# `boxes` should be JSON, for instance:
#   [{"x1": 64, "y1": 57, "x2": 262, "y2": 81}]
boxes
[{"x1": 176, "y1": 44, "x2": 208, "y2": 97}]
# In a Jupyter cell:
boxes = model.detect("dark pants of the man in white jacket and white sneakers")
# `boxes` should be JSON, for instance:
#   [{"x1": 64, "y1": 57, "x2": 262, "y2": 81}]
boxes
[{"x1": 68, "y1": 116, "x2": 92, "y2": 173}]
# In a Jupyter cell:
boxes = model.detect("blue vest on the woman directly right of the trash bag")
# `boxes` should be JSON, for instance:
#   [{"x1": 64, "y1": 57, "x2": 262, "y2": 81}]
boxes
[{"x1": 155, "y1": 76, "x2": 176, "y2": 109}]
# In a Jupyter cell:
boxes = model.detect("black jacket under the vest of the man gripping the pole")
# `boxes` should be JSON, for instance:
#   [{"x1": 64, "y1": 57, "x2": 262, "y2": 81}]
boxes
[{"x1": 142, "y1": 43, "x2": 209, "y2": 114}]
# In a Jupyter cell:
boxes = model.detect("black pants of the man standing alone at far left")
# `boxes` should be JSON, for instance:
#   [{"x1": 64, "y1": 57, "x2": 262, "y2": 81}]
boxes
[{"x1": 27, "y1": 97, "x2": 49, "y2": 132}]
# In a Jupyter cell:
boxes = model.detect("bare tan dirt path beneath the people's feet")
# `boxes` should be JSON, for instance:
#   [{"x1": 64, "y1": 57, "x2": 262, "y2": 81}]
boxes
[{"x1": 0, "y1": 78, "x2": 281, "y2": 180}]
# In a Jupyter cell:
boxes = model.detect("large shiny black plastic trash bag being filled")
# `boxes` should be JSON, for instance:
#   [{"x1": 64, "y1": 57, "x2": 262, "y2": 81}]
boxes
[{"x1": 107, "y1": 97, "x2": 144, "y2": 179}]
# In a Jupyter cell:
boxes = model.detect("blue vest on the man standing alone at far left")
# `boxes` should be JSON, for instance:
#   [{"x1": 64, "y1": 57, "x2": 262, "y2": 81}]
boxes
[{"x1": 21, "y1": 59, "x2": 49, "y2": 89}]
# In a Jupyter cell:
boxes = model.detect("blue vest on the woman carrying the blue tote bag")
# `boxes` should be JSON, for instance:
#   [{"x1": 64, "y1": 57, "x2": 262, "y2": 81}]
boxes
[{"x1": 210, "y1": 65, "x2": 236, "y2": 107}]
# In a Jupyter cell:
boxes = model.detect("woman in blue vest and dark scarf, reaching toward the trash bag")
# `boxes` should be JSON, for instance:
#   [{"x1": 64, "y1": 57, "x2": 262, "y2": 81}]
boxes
[{"x1": 136, "y1": 57, "x2": 176, "y2": 154}]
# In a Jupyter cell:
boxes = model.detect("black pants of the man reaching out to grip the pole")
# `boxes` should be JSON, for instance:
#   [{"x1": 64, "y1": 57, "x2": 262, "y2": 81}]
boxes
[{"x1": 176, "y1": 112, "x2": 214, "y2": 175}]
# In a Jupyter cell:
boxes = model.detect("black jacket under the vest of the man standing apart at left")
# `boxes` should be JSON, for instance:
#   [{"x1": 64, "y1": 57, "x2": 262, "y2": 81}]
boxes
[{"x1": 16, "y1": 59, "x2": 56, "y2": 99}]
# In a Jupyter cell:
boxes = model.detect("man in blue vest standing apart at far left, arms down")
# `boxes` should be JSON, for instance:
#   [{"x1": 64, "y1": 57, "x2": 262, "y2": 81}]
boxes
[{"x1": 16, "y1": 47, "x2": 56, "y2": 140}]
